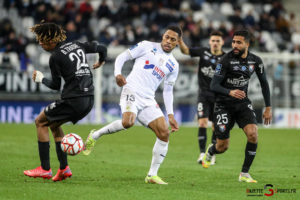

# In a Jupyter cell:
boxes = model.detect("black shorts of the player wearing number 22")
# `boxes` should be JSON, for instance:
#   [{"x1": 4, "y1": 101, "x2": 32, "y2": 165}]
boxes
[{"x1": 44, "y1": 96, "x2": 94, "y2": 124}]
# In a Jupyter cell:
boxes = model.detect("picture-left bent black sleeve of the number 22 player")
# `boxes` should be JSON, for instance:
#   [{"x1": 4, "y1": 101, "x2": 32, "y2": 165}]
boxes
[{"x1": 42, "y1": 56, "x2": 61, "y2": 90}]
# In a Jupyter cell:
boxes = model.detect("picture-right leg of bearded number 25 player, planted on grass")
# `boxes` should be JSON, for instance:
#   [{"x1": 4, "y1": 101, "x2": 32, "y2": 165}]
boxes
[{"x1": 237, "y1": 102, "x2": 258, "y2": 183}]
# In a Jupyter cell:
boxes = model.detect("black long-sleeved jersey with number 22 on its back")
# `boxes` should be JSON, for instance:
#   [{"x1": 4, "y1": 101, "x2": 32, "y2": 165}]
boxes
[{"x1": 42, "y1": 41, "x2": 107, "y2": 99}]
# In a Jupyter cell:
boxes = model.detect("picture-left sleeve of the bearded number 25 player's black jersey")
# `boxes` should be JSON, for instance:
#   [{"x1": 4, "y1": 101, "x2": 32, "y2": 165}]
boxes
[{"x1": 210, "y1": 61, "x2": 230, "y2": 95}]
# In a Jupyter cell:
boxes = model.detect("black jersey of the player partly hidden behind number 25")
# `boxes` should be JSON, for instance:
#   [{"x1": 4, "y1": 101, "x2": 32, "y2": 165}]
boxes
[{"x1": 189, "y1": 47, "x2": 225, "y2": 95}]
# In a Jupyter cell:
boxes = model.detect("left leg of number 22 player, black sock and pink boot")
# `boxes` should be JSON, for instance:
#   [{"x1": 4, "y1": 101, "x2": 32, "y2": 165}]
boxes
[{"x1": 24, "y1": 111, "x2": 52, "y2": 179}]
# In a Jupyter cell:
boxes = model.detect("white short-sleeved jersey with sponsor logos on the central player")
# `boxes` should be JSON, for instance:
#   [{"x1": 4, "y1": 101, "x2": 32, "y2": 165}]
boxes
[{"x1": 125, "y1": 41, "x2": 179, "y2": 99}]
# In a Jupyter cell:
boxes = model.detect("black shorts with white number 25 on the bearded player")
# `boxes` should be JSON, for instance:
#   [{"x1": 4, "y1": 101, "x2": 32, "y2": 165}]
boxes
[{"x1": 214, "y1": 101, "x2": 257, "y2": 140}]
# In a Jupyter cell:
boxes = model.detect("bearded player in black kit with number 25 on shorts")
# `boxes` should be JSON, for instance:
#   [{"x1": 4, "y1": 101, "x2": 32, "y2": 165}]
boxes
[{"x1": 202, "y1": 30, "x2": 272, "y2": 183}]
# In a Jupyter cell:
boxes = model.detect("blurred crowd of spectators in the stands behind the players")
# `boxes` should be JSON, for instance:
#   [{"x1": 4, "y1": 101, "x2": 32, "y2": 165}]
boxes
[{"x1": 0, "y1": 0, "x2": 300, "y2": 71}]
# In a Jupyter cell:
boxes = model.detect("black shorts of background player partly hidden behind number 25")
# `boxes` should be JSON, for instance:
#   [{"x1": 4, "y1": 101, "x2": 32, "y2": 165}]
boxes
[{"x1": 197, "y1": 92, "x2": 215, "y2": 121}]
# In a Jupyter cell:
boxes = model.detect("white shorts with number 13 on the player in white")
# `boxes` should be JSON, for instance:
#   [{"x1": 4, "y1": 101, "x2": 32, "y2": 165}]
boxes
[{"x1": 120, "y1": 87, "x2": 164, "y2": 126}]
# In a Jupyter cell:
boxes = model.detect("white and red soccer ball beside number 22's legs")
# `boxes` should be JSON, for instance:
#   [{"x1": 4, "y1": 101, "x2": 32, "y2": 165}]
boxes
[{"x1": 60, "y1": 133, "x2": 83, "y2": 156}]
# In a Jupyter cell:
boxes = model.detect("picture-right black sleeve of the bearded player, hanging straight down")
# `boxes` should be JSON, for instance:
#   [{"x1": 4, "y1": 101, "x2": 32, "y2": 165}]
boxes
[{"x1": 255, "y1": 59, "x2": 271, "y2": 107}]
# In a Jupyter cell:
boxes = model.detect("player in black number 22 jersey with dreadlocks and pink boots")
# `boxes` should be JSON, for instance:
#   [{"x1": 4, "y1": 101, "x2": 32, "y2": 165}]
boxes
[{"x1": 24, "y1": 23, "x2": 107, "y2": 181}]
